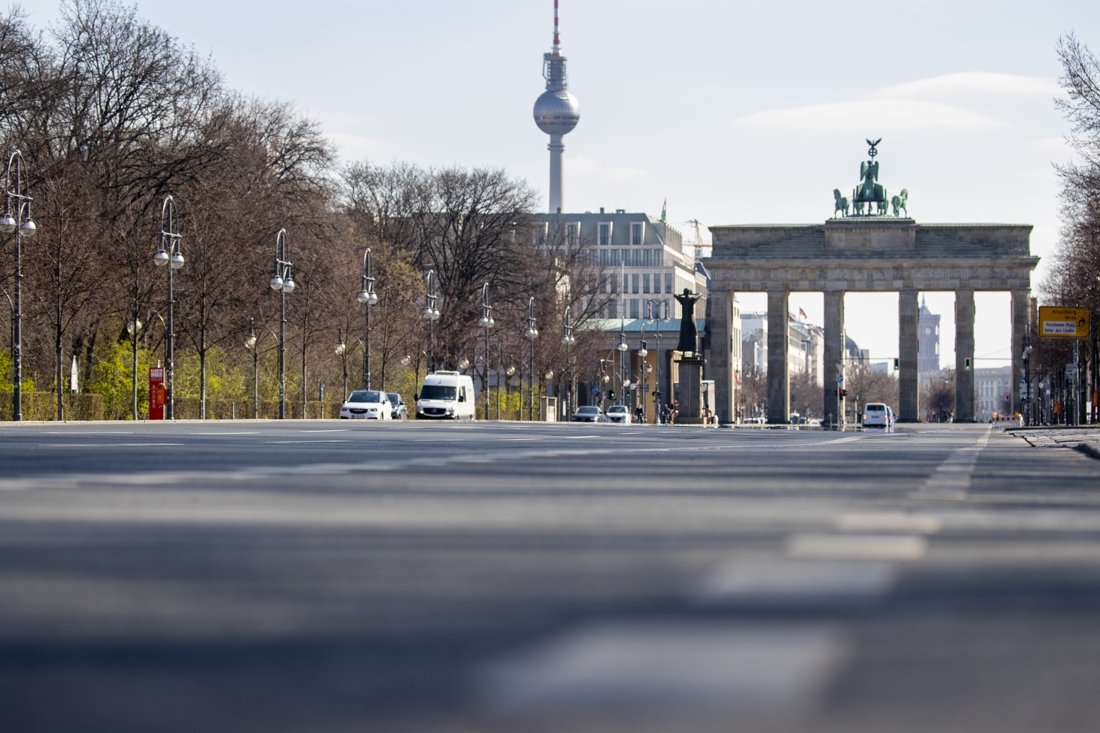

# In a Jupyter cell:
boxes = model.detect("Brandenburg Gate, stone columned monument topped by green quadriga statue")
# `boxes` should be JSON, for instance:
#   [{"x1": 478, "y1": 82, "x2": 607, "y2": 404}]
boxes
[{"x1": 704, "y1": 140, "x2": 1038, "y2": 425}]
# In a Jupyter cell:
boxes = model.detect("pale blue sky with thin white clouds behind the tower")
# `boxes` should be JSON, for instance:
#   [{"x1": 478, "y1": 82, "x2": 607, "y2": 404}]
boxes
[{"x1": 10, "y1": 0, "x2": 1100, "y2": 367}]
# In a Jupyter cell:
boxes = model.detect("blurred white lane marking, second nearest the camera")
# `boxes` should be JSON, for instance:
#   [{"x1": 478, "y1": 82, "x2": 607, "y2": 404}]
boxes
[{"x1": 692, "y1": 558, "x2": 898, "y2": 608}]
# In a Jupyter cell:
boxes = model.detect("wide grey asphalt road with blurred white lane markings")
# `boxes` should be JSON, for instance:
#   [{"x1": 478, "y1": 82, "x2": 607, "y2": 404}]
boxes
[{"x1": 0, "y1": 420, "x2": 1100, "y2": 733}]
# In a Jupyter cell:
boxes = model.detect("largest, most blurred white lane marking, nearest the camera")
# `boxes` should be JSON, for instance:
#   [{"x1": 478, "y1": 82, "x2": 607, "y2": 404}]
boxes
[{"x1": 477, "y1": 621, "x2": 848, "y2": 717}]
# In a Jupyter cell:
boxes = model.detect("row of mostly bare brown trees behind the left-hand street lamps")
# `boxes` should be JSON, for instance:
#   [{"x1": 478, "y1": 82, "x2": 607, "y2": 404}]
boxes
[{"x1": 0, "y1": 0, "x2": 607, "y2": 415}]
